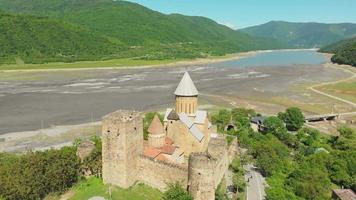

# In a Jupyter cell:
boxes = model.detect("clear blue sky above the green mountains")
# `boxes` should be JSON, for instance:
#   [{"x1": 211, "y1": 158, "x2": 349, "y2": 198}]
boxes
[{"x1": 125, "y1": 0, "x2": 356, "y2": 29}]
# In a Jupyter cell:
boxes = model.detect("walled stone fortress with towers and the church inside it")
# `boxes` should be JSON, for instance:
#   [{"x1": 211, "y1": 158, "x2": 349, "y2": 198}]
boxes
[{"x1": 102, "y1": 72, "x2": 237, "y2": 200}]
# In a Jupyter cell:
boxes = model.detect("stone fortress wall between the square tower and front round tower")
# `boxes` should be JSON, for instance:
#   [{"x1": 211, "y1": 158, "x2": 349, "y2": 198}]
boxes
[{"x1": 138, "y1": 155, "x2": 188, "y2": 191}]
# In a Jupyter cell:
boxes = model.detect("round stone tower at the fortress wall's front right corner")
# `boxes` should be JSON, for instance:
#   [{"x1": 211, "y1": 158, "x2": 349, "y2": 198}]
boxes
[{"x1": 188, "y1": 152, "x2": 215, "y2": 200}]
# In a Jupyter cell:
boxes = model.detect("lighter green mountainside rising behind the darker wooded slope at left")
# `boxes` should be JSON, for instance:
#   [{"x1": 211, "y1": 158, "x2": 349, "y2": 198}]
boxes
[{"x1": 0, "y1": 0, "x2": 286, "y2": 64}]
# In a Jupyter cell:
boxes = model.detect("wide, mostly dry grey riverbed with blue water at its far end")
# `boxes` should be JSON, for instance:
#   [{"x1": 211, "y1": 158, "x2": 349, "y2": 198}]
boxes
[{"x1": 0, "y1": 50, "x2": 347, "y2": 134}]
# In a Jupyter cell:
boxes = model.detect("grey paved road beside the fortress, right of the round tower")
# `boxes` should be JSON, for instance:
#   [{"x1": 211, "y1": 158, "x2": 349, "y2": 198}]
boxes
[{"x1": 244, "y1": 164, "x2": 266, "y2": 200}]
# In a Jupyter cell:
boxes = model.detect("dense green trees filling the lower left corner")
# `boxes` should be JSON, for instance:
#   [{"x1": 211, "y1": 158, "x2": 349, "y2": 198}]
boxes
[{"x1": 0, "y1": 147, "x2": 80, "y2": 199}]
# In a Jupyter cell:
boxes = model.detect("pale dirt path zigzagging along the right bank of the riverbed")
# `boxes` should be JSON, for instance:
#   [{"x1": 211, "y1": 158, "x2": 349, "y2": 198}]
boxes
[{"x1": 308, "y1": 65, "x2": 356, "y2": 108}]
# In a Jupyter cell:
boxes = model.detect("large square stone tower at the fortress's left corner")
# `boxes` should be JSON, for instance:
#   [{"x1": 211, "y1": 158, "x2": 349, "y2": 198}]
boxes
[{"x1": 102, "y1": 110, "x2": 143, "y2": 188}]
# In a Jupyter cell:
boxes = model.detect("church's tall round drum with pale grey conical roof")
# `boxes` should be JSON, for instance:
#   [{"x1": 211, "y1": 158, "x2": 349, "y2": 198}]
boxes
[{"x1": 174, "y1": 72, "x2": 199, "y2": 115}]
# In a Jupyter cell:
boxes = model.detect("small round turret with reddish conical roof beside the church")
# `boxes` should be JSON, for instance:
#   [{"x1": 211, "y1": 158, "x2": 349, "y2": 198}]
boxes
[{"x1": 148, "y1": 115, "x2": 166, "y2": 148}]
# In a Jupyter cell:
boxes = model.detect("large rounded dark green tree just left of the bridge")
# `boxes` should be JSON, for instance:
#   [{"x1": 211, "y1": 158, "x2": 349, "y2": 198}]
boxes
[{"x1": 278, "y1": 107, "x2": 305, "y2": 131}]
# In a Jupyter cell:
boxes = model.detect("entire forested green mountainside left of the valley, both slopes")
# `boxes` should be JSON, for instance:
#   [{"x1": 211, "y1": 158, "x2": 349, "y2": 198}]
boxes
[{"x1": 0, "y1": 0, "x2": 287, "y2": 63}]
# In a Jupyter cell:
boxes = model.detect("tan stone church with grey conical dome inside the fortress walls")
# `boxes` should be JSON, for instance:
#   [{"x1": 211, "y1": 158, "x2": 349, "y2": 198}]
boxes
[{"x1": 145, "y1": 72, "x2": 216, "y2": 164}]
